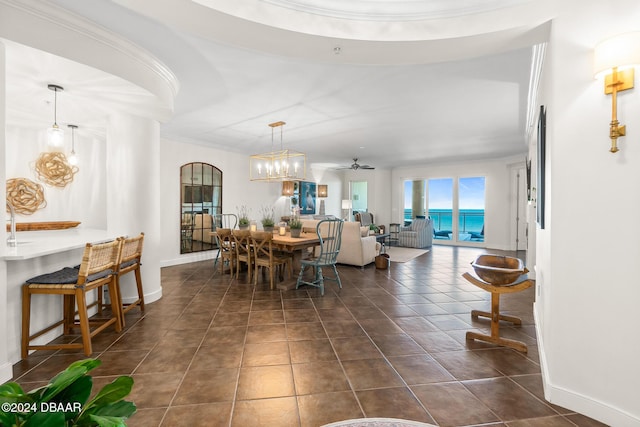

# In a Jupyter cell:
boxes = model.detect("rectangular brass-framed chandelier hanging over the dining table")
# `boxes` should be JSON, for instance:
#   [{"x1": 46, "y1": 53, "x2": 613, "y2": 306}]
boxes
[{"x1": 249, "y1": 121, "x2": 307, "y2": 182}]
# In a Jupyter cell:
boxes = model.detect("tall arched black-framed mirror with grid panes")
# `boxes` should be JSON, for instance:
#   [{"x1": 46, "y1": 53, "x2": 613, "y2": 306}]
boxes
[{"x1": 180, "y1": 162, "x2": 222, "y2": 254}]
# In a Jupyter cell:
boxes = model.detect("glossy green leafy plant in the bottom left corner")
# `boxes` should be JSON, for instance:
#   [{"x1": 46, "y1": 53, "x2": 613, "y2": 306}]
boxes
[{"x1": 0, "y1": 359, "x2": 136, "y2": 427}]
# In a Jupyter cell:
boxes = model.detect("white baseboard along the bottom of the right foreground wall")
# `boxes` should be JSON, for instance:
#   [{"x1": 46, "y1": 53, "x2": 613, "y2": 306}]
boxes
[{"x1": 533, "y1": 303, "x2": 640, "y2": 427}]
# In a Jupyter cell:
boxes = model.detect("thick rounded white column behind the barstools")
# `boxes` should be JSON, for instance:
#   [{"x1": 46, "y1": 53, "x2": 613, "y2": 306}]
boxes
[{"x1": 107, "y1": 114, "x2": 162, "y2": 303}]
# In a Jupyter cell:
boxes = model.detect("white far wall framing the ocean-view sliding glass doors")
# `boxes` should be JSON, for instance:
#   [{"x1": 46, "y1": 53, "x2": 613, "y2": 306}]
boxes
[{"x1": 391, "y1": 156, "x2": 526, "y2": 250}]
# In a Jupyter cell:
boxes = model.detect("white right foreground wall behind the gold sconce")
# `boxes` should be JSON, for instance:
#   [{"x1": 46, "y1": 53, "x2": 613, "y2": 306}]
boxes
[{"x1": 535, "y1": 0, "x2": 640, "y2": 426}]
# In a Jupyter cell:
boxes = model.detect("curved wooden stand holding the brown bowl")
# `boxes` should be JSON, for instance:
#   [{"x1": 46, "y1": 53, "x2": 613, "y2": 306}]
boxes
[{"x1": 462, "y1": 273, "x2": 534, "y2": 353}]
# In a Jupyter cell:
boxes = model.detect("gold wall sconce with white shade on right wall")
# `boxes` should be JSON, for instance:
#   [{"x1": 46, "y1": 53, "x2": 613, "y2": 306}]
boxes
[{"x1": 594, "y1": 32, "x2": 640, "y2": 153}]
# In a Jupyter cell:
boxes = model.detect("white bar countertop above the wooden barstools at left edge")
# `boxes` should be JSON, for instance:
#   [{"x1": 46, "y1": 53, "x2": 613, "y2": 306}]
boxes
[{"x1": 0, "y1": 228, "x2": 118, "y2": 261}]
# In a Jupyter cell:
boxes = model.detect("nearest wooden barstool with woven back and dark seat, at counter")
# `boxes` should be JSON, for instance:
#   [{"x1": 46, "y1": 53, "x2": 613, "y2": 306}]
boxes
[{"x1": 22, "y1": 238, "x2": 122, "y2": 359}]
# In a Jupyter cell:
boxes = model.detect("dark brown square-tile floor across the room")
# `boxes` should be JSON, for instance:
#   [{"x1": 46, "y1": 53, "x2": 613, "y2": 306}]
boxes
[{"x1": 14, "y1": 246, "x2": 602, "y2": 427}]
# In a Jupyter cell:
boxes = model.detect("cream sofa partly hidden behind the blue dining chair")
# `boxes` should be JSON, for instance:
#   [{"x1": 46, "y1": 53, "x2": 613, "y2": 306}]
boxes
[{"x1": 302, "y1": 219, "x2": 381, "y2": 267}]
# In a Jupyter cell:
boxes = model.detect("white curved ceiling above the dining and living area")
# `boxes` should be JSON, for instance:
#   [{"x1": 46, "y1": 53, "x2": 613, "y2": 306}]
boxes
[{"x1": 8, "y1": 0, "x2": 548, "y2": 171}]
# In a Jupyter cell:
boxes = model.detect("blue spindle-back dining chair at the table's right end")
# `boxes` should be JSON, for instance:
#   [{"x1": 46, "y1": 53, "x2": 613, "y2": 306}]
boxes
[{"x1": 296, "y1": 219, "x2": 344, "y2": 295}]
